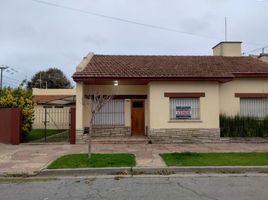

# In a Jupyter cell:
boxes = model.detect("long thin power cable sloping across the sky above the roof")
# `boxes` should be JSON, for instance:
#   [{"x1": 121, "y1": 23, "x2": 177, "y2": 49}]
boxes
[{"x1": 31, "y1": 0, "x2": 260, "y2": 45}]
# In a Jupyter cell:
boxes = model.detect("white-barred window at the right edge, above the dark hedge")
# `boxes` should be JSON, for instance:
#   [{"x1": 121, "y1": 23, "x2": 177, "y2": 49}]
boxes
[{"x1": 240, "y1": 98, "x2": 267, "y2": 118}]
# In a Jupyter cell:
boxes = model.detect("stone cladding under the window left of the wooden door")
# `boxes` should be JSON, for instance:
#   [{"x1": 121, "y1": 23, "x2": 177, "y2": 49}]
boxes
[{"x1": 92, "y1": 126, "x2": 131, "y2": 137}]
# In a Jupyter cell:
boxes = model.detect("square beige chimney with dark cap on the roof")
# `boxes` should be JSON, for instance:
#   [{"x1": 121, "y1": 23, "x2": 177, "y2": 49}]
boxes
[{"x1": 212, "y1": 41, "x2": 242, "y2": 56}]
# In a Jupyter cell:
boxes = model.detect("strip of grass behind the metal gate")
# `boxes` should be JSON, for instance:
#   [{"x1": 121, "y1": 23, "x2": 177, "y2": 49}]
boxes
[{"x1": 23, "y1": 129, "x2": 67, "y2": 142}]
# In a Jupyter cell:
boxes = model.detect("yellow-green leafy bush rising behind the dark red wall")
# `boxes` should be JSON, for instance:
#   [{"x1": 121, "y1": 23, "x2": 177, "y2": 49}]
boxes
[{"x1": 0, "y1": 87, "x2": 34, "y2": 135}]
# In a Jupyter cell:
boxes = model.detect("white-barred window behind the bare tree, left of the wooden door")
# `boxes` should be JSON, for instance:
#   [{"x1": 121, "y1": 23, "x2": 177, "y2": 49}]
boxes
[{"x1": 93, "y1": 99, "x2": 125, "y2": 125}]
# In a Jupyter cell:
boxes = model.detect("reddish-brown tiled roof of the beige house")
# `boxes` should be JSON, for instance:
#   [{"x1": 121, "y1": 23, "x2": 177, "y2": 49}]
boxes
[{"x1": 73, "y1": 55, "x2": 268, "y2": 80}]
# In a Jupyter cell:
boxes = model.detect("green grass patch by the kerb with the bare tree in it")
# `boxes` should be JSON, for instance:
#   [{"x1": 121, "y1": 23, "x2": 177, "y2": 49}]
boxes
[{"x1": 48, "y1": 153, "x2": 136, "y2": 169}]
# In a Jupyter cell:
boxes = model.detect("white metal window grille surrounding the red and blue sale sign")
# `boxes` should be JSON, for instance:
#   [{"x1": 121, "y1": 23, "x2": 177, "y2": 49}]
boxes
[{"x1": 169, "y1": 98, "x2": 200, "y2": 120}]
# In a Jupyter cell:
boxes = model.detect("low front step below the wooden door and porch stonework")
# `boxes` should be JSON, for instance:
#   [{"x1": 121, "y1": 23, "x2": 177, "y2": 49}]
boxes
[{"x1": 92, "y1": 136, "x2": 149, "y2": 144}]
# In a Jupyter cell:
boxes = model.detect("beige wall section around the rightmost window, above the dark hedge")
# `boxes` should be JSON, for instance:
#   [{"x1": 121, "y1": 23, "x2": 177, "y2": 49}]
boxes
[{"x1": 220, "y1": 78, "x2": 268, "y2": 115}]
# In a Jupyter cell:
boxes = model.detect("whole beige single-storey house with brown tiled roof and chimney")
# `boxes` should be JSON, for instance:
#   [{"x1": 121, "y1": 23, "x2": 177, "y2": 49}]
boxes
[{"x1": 73, "y1": 42, "x2": 268, "y2": 142}]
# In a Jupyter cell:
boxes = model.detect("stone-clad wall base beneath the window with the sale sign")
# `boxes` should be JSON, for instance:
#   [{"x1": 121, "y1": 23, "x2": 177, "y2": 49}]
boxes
[{"x1": 148, "y1": 128, "x2": 220, "y2": 143}]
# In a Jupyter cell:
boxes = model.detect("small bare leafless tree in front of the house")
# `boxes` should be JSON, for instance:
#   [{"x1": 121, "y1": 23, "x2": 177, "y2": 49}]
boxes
[{"x1": 87, "y1": 91, "x2": 113, "y2": 158}]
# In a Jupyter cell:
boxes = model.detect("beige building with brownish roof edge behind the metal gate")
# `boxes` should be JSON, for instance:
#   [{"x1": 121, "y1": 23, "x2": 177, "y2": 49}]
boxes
[{"x1": 33, "y1": 88, "x2": 75, "y2": 129}]
